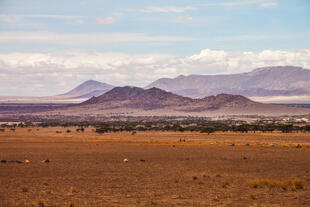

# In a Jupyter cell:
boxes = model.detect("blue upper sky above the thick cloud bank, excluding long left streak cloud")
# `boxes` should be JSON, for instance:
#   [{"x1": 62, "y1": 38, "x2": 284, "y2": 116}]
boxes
[{"x1": 0, "y1": 0, "x2": 310, "y2": 56}]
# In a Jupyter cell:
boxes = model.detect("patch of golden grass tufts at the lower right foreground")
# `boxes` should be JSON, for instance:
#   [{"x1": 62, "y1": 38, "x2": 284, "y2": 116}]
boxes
[{"x1": 247, "y1": 178, "x2": 306, "y2": 191}]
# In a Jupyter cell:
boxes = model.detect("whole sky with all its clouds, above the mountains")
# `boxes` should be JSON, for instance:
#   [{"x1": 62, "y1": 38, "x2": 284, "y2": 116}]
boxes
[{"x1": 0, "y1": 0, "x2": 310, "y2": 96}]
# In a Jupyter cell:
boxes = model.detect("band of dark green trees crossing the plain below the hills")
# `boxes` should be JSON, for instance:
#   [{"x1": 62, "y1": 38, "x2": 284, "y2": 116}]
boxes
[{"x1": 1, "y1": 119, "x2": 310, "y2": 134}]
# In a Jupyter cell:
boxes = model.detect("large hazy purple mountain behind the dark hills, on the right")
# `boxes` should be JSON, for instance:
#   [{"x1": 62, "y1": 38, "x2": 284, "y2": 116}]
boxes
[{"x1": 146, "y1": 66, "x2": 310, "y2": 97}]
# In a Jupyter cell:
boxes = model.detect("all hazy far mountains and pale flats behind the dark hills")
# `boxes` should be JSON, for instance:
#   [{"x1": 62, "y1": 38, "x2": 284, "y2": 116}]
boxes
[{"x1": 0, "y1": 66, "x2": 310, "y2": 103}]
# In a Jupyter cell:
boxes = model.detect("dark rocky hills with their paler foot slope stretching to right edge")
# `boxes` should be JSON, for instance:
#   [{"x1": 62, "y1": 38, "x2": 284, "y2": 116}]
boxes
[{"x1": 49, "y1": 86, "x2": 310, "y2": 117}]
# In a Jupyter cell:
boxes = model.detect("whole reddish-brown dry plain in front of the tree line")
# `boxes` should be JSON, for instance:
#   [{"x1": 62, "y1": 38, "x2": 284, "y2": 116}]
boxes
[{"x1": 0, "y1": 128, "x2": 310, "y2": 207}]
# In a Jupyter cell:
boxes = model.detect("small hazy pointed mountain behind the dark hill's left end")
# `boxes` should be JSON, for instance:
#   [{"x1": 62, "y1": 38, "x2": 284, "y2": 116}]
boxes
[{"x1": 58, "y1": 80, "x2": 114, "y2": 98}]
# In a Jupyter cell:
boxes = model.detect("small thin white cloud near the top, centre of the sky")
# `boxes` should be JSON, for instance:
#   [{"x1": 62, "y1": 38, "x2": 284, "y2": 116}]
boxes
[{"x1": 126, "y1": 6, "x2": 196, "y2": 13}]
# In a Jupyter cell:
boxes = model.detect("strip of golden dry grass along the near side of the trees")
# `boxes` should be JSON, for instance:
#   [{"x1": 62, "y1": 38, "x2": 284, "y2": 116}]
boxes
[{"x1": 0, "y1": 127, "x2": 310, "y2": 149}]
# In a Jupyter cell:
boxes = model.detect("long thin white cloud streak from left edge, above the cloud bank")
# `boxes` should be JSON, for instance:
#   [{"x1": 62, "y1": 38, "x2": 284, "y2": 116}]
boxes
[{"x1": 0, "y1": 32, "x2": 193, "y2": 45}]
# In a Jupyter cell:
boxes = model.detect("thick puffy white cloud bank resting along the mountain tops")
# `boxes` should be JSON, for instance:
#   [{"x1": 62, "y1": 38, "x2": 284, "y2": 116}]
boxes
[{"x1": 0, "y1": 49, "x2": 310, "y2": 95}]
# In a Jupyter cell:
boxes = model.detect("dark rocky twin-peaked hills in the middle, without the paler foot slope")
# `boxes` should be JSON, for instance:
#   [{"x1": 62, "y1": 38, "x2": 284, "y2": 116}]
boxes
[{"x1": 82, "y1": 86, "x2": 255, "y2": 111}]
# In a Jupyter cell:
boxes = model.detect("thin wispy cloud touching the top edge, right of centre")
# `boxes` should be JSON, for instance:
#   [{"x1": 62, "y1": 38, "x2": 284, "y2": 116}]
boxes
[{"x1": 203, "y1": 0, "x2": 277, "y2": 7}]
